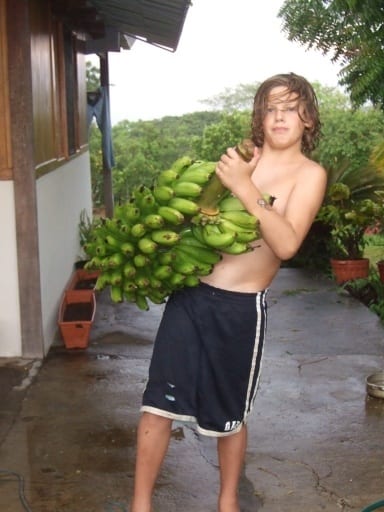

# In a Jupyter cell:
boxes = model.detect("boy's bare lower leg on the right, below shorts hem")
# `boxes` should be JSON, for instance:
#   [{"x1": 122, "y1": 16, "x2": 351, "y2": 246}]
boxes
[{"x1": 217, "y1": 426, "x2": 247, "y2": 512}]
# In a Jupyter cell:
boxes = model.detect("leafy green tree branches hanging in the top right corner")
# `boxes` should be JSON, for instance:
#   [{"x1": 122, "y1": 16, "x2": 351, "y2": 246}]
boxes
[{"x1": 278, "y1": 0, "x2": 384, "y2": 109}]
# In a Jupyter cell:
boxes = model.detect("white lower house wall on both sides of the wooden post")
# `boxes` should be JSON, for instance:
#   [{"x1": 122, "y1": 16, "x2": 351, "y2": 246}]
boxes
[{"x1": 0, "y1": 152, "x2": 92, "y2": 357}]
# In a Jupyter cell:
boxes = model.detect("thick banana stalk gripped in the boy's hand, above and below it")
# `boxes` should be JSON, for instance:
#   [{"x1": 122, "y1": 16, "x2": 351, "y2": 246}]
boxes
[{"x1": 197, "y1": 139, "x2": 255, "y2": 216}]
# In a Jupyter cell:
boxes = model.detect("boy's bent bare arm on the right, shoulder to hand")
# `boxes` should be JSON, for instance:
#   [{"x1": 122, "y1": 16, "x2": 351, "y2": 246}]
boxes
[{"x1": 216, "y1": 148, "x2": 327, "y2": 260}]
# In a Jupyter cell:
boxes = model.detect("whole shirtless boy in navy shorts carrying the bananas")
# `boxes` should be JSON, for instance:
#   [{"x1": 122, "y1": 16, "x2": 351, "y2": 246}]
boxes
[{"x1": 131, "y1": 73, "x2": 326, "y2": 512}]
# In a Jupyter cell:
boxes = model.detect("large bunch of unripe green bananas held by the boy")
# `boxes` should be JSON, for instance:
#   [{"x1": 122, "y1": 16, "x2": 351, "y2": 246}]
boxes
[{"x1": 84, "y1": 144, "x2": 272, "y2": 310}]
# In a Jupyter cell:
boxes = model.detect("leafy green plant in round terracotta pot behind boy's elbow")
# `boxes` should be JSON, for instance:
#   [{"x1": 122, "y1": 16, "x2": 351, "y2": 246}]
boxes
[{"x1": 317, "y1": 182, "x2": 383, "y2": 284}]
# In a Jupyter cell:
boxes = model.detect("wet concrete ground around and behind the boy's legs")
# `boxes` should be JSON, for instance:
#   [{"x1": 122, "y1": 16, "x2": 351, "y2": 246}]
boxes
[{"x1": 0, "y1": 269, "x2": 384, "y2": 512}]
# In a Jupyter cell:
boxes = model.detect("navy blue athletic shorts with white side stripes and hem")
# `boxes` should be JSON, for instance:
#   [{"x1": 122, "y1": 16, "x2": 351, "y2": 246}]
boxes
[{"x1": 141, "y1": 283, "x2": 267, "y2": 437}]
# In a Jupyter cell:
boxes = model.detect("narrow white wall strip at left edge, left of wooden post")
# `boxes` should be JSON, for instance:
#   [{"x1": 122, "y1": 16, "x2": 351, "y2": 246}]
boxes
[{"x1": 0, "y1": 181, "x2": 21, "y2": 357}]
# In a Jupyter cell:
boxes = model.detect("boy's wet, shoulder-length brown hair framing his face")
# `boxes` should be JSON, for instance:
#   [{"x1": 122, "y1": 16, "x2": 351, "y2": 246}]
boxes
[{"x1": 251, "y1": 73, "x2": 321, "y2": 154}]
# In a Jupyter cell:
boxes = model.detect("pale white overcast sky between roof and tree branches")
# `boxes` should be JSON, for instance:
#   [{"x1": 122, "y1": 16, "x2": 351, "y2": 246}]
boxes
[{"x1": 100, "y1": 0, "x2": 339, "y2": 125}]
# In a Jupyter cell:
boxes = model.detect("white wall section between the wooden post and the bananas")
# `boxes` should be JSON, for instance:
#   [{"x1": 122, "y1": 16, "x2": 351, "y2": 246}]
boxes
[{"x1": 37, "y1": 152, "x2": 92, "y2": 353}]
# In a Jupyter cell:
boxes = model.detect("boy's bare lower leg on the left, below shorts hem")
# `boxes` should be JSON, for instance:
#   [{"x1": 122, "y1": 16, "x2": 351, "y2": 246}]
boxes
[{"x1": 131, "y1": 412, "x2": 172, "y2": 512}]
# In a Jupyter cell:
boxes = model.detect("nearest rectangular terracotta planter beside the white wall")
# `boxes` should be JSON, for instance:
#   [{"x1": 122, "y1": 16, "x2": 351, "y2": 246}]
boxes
[{"x1": 58, "y1": 290, "x2": 96, "y2": 349}]
